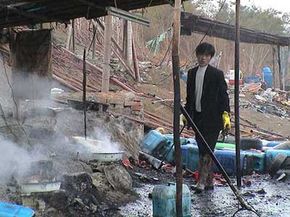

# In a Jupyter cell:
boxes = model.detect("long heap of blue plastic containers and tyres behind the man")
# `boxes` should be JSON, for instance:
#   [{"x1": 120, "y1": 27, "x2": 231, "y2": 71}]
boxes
[{"x1": 140, "y1": 130, "x2": 290, "y2": 183}]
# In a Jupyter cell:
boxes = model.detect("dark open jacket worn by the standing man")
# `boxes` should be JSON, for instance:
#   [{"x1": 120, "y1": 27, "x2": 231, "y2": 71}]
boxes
[{"x1": 185, "y1": 65, "x2": 230, "y2": 130}]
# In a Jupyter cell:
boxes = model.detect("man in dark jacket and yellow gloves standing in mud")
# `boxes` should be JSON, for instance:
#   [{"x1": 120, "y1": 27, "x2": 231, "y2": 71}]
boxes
[{"x1": 182, "y1": 42, "x2": 230, "y2": 193}]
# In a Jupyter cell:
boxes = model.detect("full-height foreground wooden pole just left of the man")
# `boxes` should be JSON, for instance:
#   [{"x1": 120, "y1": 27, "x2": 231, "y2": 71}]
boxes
[{"x1": 172, "y1": 0, "x2": 183, "y2": 217}]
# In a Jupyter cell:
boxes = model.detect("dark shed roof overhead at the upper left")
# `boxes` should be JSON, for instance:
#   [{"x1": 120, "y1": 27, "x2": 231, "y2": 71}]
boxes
[{"x1": 0, "y1": 0, "x2": 177, "y2": 28}]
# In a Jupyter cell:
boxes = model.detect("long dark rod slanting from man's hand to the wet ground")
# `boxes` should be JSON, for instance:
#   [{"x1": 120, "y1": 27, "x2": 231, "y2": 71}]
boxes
[{"x1": 180, "y1": 104, "x2": 259, "y2": 216}]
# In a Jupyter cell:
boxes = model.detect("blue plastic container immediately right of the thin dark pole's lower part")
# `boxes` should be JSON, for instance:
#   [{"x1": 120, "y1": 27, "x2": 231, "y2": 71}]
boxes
[{"x1": 243, "y1": 150, "x2": 266, "y2": 174}]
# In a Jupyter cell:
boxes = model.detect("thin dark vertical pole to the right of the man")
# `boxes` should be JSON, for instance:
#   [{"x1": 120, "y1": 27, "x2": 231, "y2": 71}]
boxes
[{"x1": 235, "y1": 0, "x2": 242, "y2": 187}]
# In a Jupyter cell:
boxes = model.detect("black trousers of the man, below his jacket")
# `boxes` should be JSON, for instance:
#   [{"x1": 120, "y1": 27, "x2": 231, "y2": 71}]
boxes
[{"x1": 194, "y1": 113, "x2": 220, "y2": 156}]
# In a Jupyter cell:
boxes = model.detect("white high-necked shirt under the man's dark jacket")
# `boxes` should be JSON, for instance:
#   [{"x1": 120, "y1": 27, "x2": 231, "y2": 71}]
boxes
[{"x1": 195, "y1": 65, "x2": 208, "y2": 112}]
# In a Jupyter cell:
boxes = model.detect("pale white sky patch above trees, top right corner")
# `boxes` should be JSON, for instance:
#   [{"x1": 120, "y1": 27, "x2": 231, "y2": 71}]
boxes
[{"x1": 241, "y1": 0, "x2": 290, "y2": 13}]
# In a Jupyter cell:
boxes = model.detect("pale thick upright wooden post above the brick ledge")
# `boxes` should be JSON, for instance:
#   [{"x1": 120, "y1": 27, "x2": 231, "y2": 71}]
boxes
[{"x1": 102, "y1": 15, "x2": 112, "y2": 92}]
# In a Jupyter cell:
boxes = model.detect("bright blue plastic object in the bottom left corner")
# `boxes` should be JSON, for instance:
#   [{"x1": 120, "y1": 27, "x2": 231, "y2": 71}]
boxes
[{"x1": 0, "y1": 202, "x2": 34, "y2": 217}]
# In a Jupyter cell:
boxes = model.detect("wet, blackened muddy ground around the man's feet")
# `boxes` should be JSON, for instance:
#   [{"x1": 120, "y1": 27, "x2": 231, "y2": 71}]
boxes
[{"x1": 120, "y1": 165, "x2": 290, "y2": 217}]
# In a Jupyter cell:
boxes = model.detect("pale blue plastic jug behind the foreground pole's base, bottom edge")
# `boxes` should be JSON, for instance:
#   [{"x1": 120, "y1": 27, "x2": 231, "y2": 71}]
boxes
[{"x1": 152, "y1": 183, "x2": 191, "y2": 217}]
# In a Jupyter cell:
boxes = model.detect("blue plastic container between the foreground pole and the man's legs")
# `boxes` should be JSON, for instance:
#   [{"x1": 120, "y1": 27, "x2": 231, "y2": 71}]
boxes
[{"x1": 181, "y1": 144, "x2": 199, "y2": 171}]
